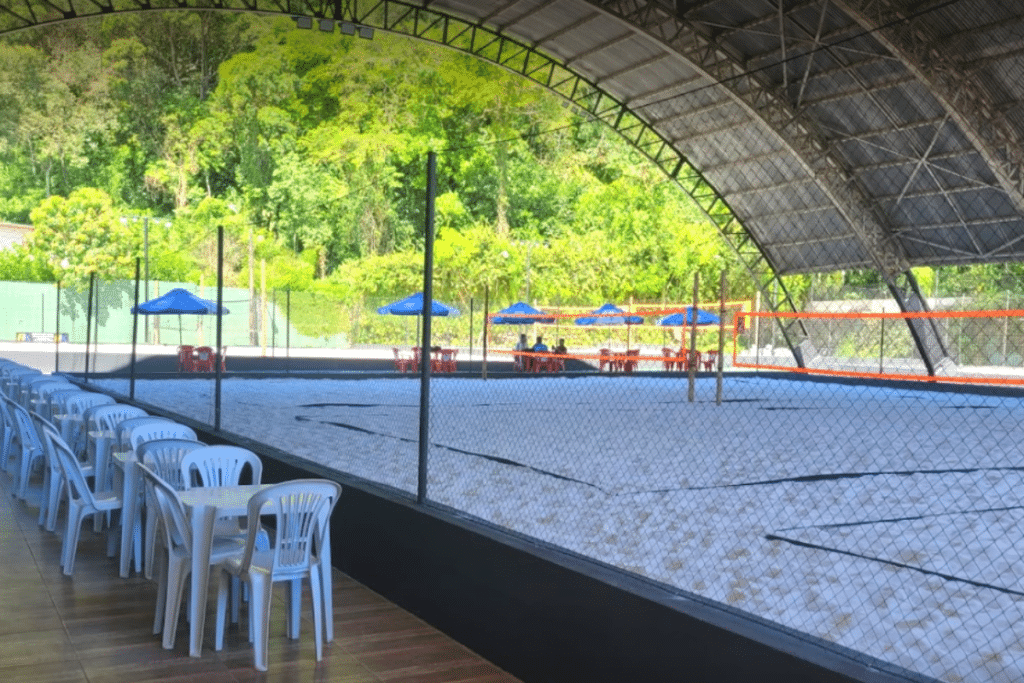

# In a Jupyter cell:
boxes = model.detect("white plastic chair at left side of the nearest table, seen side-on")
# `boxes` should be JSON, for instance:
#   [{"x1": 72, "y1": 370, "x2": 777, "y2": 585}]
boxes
[{"x1": 138, "y1": 464, "x2": 245, "y2": 650}]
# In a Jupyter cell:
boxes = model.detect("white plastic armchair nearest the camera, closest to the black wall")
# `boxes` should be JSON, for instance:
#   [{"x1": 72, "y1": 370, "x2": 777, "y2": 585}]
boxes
[{"x1": 214, "y1": 479, "x2": 341, "y2": 671}]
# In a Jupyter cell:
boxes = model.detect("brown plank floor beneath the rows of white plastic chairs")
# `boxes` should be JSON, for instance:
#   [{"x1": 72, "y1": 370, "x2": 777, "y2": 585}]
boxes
[{"x1": 0, "y1": 474, "x2": 517, "y2": 683}]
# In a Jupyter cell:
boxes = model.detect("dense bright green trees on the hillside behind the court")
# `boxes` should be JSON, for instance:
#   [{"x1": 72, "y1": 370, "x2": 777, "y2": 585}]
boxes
[{"x1": 0, "y1": 12, "x2": 1019, "y2": 342}]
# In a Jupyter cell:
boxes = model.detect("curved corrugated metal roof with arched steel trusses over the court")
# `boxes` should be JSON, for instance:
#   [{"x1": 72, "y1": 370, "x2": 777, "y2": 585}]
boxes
[{"x1": 0, "y1": 0, "x2": 1024, "y2": 370}]
